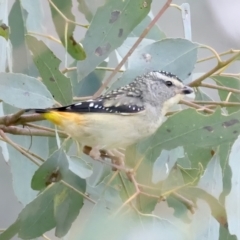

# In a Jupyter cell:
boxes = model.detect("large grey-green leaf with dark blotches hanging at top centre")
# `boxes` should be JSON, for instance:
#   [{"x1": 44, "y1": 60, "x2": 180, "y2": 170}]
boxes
[{"x1": 78, "y1": 0, "x2": 151, "y2": 80}]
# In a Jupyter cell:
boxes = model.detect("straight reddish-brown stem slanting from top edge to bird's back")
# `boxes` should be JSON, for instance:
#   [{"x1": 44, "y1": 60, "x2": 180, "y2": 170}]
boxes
[{"x1": 93, "y1": 0, "x2": 172, "y2": 98}]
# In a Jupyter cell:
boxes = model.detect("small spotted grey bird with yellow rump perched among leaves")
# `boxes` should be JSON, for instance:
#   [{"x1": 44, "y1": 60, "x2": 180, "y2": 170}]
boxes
[{"x1": 26, "y1": 71, "x2": 193, "y2": 158}]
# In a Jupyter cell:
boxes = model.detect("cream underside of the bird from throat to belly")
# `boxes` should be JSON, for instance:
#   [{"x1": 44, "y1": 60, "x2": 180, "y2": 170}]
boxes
[{"x1": 57, "y1": 94, "x2": 182, "y2": 150}]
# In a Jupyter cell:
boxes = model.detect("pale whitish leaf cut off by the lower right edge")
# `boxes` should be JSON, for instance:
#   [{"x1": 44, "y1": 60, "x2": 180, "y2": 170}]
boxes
[{"x1": 225, "y1": 137, "x2": 240, "y2": 239}]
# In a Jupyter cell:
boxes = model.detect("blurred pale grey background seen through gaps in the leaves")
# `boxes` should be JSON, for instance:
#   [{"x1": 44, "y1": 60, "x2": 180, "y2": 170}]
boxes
[{"x1": 0, "y1": 0, "x2": 240, "y2": 239}]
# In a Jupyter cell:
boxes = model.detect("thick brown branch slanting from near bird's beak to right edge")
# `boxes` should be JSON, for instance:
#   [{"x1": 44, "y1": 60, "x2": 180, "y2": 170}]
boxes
[{"x1": 189, "y1": 52, "x2": 240, "y2": 87}]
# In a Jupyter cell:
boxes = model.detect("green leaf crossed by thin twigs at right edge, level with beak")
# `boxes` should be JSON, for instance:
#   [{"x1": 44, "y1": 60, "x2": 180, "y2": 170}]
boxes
[{"x1": 211, "y1": 76, "x2": 240, "y2": 114}]
